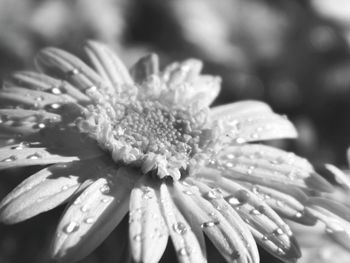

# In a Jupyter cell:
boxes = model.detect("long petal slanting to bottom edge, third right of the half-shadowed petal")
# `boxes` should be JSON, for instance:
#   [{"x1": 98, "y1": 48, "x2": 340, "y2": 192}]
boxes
[{"x1": 173, "y1": 183, "x2": 258, "y2": 263}]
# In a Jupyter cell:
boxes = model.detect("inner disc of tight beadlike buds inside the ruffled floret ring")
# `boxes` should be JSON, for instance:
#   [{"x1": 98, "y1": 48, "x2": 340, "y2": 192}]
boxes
[{"x1": 114, "y1": 102, "x2": 200, "y2": 156}]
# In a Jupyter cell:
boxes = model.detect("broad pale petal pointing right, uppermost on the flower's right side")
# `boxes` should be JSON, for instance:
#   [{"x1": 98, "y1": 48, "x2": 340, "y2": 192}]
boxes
[{"x1": 210, "y1": 101, "x2": 297, "y2": 144}]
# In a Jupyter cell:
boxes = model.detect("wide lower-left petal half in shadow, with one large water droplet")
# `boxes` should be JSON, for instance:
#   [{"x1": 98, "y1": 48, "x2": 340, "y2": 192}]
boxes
[{"x1": 52, "y1": 167, "x2": 139, "y2": 262}]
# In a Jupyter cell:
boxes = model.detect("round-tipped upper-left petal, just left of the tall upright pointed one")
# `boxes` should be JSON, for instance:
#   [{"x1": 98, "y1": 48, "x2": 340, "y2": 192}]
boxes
[{"x1": 36, "y1": 48, "x2": 106, "y2": 95}]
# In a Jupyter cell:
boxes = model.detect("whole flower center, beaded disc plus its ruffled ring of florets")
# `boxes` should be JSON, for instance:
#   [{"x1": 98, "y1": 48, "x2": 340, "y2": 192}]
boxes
[{"x1": 77, "y1": 100, "x2": 212, "y2": 179}]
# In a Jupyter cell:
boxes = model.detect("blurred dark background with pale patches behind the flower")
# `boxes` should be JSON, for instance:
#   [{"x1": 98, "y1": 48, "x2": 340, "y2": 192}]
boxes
[{"x1": 0, "y1": 0, "x2": 350, "y2": 263}]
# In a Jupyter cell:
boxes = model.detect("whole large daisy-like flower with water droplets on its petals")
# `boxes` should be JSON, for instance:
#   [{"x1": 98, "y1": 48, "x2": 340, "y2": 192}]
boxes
[{"x1": 0, "y1": 41, "x2": 348, "y2": 262}]
